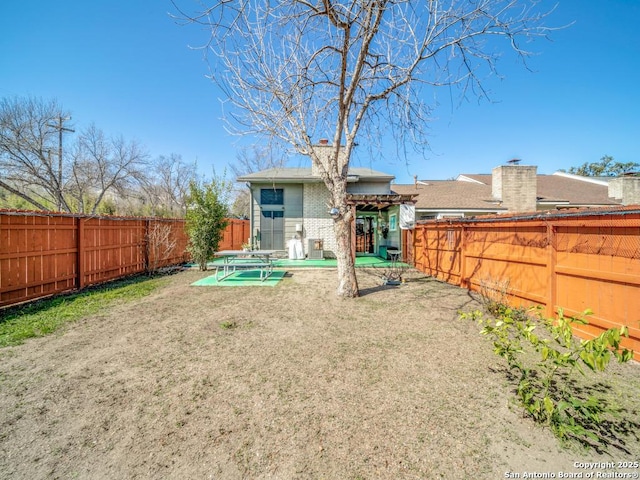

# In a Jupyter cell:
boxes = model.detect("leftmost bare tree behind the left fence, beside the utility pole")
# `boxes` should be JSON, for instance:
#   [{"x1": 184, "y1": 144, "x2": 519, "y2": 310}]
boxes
[{"x1": 0, "y1": 97, "x2": 71, "y2": 212}]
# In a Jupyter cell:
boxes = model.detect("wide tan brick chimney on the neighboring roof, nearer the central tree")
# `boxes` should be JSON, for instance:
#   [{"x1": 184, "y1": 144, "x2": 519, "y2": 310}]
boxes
[{"x1": 491, "y1": 161, "x2": 538, "y2": 212}]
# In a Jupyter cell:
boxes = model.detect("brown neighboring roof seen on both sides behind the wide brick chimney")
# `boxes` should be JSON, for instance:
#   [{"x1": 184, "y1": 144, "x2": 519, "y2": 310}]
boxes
[{"x1": 458, "y1": 172, "x2": 620, "y2": 207}]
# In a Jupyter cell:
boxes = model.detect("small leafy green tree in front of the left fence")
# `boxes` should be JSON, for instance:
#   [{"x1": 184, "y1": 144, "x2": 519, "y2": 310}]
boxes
[{"x1": 186, "y1": 181, "x2": 228, "y2": 271}]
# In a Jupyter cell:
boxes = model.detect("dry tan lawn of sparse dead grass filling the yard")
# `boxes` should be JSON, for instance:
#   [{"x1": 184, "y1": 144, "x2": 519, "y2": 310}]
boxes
[{"x1": 0, "y1": 270, "x2": 640, "y2": 479}]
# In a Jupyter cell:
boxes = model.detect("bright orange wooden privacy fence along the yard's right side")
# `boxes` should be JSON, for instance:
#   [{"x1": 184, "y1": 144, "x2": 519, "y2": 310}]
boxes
[{"x1": 412, "y1": 206, "x2": 640, "y2": 360}]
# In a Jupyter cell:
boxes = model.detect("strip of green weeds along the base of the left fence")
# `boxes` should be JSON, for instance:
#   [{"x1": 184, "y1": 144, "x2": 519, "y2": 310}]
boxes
[{"x1": 0, "y1": 277, "x2": 163, "y2": 347}]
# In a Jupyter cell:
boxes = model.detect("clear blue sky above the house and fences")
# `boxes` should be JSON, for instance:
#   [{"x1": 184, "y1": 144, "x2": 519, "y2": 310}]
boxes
[{"x1": 0, "y1": 0, "x2": 640, "y2": 183}]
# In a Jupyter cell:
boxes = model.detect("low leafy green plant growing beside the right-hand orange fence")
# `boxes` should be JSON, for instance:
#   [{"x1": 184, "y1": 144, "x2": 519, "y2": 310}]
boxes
[{"x1": 460, "y1": 301, "x2": 633, "y2": 446}]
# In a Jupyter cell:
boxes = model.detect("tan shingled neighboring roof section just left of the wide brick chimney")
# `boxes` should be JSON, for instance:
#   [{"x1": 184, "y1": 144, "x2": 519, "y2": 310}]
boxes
[{"x1": 391, "y1": 181, "x2": 506, "y2": 212}]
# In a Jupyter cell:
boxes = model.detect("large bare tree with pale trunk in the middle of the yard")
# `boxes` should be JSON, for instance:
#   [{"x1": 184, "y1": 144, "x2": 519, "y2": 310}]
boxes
[{"x1": 176, "y1": 0, "x2": 548, "y2": 297}]
